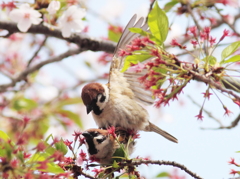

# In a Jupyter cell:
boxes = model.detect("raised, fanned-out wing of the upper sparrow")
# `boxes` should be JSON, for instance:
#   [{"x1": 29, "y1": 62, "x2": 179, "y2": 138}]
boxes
[{"x1": 109, "y1": 14, "x2": 154, "y2": 105}]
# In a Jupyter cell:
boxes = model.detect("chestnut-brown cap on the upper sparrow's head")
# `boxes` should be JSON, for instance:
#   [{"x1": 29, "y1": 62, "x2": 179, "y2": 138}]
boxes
[{"x1": 81, "y1": 83, "x2": 105, "y2": 106}]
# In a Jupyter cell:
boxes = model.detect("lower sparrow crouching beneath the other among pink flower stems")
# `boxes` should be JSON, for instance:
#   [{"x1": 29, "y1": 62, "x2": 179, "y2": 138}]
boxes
[{"x1": 82, "y1": 129, "x2": 135, "y2": 164}]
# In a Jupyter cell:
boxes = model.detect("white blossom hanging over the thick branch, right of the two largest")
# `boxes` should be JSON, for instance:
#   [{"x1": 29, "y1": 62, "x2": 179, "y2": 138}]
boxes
[{"x1": 59, "y1": 6, "x2": 86, "y2": 37}]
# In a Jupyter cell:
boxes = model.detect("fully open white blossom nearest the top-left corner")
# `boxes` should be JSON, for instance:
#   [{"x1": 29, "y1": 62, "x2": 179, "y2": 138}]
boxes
[{"x1": 10, "y1": 3, "x2": 42, "y2": 32}]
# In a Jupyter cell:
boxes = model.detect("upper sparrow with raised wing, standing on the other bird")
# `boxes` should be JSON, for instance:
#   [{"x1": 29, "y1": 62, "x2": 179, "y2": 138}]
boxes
[{"x1": 81, "y1": 15, "x2": 178, "y2": 143}]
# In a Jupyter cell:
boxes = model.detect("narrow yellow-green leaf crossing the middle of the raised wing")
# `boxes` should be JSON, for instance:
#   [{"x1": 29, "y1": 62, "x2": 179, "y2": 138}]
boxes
[{"x1": 122, "y1": 55, "x2": 152, "y2": 72}]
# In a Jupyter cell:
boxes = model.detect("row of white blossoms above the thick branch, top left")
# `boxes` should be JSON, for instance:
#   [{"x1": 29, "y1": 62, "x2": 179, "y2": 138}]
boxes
[{"x1": 5, "y1": 0, "x2": 86, "y2": 38}]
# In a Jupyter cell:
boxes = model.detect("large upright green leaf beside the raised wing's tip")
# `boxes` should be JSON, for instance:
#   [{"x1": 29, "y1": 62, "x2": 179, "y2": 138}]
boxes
[{"x1": 148, "y1": 1, "x2": 168, "y2": 45}]
